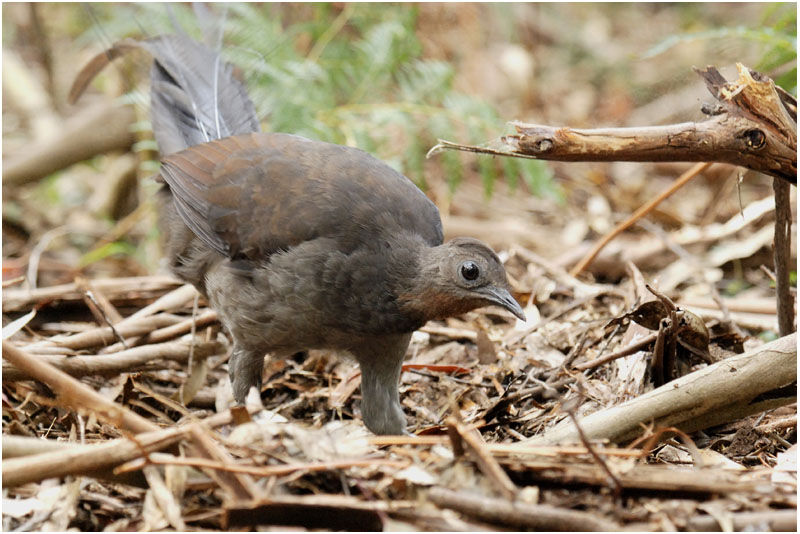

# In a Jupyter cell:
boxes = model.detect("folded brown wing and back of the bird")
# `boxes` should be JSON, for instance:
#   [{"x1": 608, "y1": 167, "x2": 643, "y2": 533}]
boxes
[{"x1": 161, "y1": 133, "x2": 442, "y2": 259}]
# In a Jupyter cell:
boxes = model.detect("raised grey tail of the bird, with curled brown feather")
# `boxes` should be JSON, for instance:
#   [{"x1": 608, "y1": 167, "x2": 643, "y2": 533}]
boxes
[{"x1": 69, "y1": 33, "x2": 260, "y2": 156}]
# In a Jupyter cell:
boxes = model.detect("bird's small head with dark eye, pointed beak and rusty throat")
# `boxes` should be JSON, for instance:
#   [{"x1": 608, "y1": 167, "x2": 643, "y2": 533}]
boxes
[{"x1": 401, "y1": 237, "x2": 525, "y2": 320}]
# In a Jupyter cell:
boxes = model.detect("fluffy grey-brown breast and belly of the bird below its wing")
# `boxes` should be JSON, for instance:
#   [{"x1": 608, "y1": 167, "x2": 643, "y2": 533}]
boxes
[{"x1": 206, "y1": 243, "x2": 420, "y2": 353}]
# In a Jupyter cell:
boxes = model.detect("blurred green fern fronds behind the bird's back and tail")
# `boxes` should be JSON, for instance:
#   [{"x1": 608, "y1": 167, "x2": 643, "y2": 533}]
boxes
[{"x1": 84, "y1": 3, "x2": 553, "y2": 199}]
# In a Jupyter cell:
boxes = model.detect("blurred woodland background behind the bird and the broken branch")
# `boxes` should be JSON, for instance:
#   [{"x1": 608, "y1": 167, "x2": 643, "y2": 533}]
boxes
[{"x1": 3, "y1": 3, "x2": 797, "y2": 289}]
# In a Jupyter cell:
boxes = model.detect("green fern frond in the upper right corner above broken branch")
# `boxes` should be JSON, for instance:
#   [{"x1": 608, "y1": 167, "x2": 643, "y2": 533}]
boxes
[{"x1": 643, "y1": 4, "x2": 797, "y2": 95}]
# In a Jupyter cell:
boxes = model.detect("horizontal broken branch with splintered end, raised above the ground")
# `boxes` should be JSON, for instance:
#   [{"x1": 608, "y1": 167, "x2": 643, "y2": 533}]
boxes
[{"x1": 431, "y1": 64, "x2": 797, "y2": 184}]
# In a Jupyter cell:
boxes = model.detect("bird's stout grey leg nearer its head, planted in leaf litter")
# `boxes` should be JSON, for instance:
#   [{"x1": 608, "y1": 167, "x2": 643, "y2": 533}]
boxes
[{"x1": 354, "y1": 335, "x2": 411, "y2": 434}]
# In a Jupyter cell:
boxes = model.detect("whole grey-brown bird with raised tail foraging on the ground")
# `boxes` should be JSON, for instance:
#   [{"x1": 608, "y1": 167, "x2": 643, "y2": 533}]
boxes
[{"x1": 72, "y1": 34, "x2": 524, "y2": 434}]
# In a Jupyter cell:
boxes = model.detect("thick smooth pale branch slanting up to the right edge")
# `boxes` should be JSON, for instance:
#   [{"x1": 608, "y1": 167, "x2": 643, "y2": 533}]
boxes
[{"x1": 521, "y1": 334, "x2": 797, "y2": 444}]
